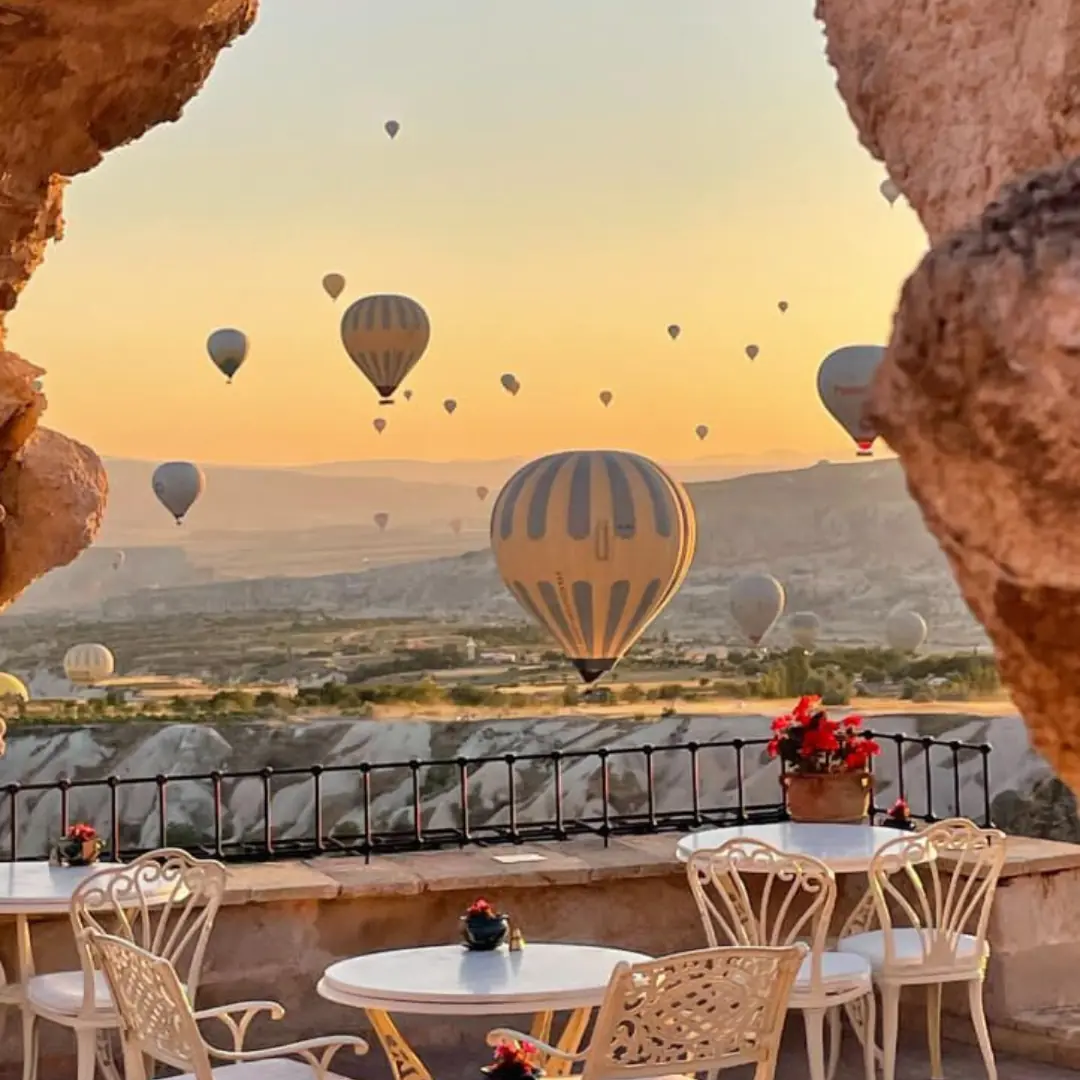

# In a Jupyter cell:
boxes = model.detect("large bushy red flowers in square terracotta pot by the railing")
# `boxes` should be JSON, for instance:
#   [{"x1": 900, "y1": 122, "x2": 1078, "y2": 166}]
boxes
[{"x1": 768, "y1": 697, "x2": 881, "y2": 824}]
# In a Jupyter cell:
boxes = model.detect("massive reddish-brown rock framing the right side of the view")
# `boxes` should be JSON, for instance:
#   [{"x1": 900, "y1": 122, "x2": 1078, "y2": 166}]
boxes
[{"x1": 816, "y1": 0, "x2": 1080, "y2": 792}]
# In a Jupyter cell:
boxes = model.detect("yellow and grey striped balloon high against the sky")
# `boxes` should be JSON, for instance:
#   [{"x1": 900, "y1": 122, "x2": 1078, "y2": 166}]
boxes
[{"x1": 341, "y1": 295, "x2": 431, "y2": 405}]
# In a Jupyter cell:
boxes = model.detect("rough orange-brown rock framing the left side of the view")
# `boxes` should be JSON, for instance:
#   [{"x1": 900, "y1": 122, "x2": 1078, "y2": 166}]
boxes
[{"x1": 0, "y1": 0, "x2": 257, "y2": 608}]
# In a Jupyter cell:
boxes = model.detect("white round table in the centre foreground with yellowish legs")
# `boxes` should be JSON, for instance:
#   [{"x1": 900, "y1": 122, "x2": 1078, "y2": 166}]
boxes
[{"x1": 318, "y1": 943, "x2": 651, "y2": 1080}]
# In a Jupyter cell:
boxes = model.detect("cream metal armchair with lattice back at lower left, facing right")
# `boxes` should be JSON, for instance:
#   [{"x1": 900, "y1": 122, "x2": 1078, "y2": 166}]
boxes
[{"x1": 85, "y1": 929, "x2": 367, "y2": 1080}]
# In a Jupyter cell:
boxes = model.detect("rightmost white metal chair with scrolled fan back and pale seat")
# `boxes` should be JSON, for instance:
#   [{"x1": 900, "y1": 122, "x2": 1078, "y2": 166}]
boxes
[{"x1": 837, "y1": 818, "x2": 1005, "y2": 1080}]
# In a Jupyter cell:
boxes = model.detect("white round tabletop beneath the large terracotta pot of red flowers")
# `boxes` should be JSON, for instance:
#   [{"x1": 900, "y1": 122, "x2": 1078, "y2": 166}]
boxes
[{"x1": 675, "y1": 821, "x2": 909, "y2": 874}]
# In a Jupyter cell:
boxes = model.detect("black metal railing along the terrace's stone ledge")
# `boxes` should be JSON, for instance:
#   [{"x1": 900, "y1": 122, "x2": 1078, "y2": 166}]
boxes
[{"x1": 0, "y1": 732, "x2": 991, "y2": 862}]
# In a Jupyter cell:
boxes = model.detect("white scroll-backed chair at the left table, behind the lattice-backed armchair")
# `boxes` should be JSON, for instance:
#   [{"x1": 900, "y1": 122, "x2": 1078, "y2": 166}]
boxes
[{"x1": 23, "y1": 849, "x2": 226, "y2": 1080}]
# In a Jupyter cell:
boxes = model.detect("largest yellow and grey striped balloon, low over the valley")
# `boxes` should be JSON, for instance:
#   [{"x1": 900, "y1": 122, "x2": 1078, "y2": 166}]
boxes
[{"x1": 491, "y1": 450, "x2": 696, "y2": 683}]
